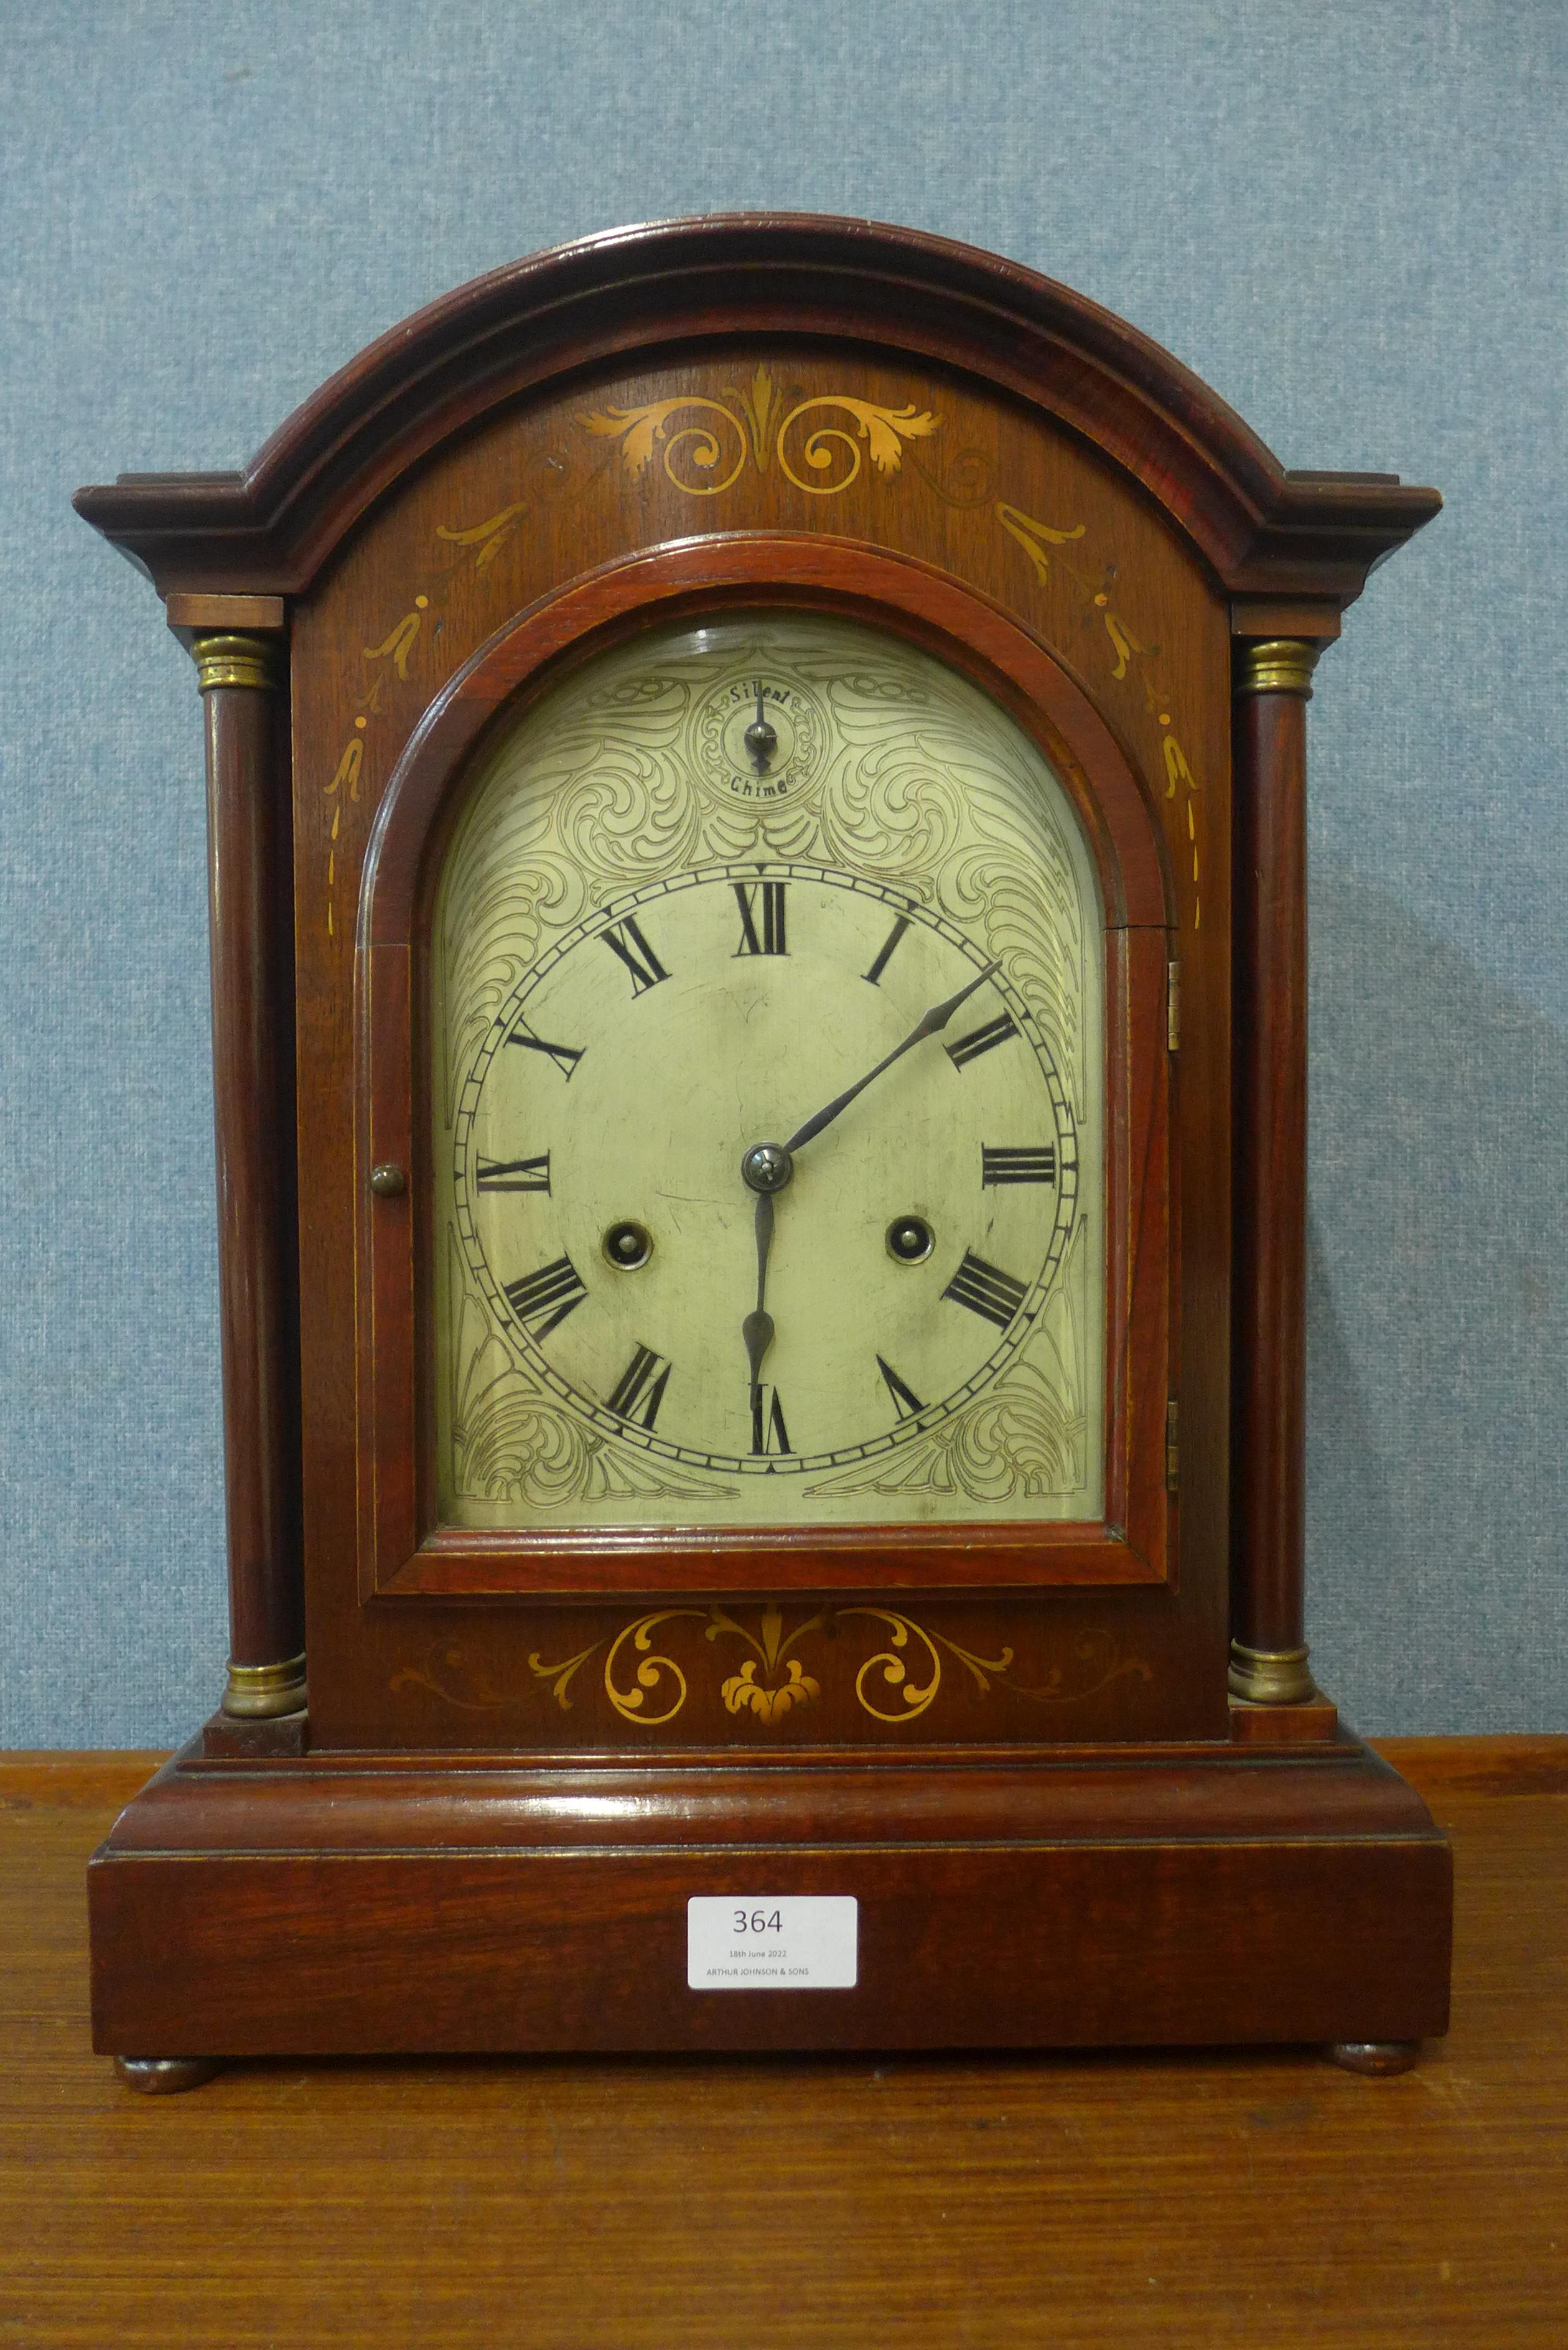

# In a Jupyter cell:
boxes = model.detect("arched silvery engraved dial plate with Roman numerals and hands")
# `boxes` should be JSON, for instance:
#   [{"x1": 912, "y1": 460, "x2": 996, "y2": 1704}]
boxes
[{"x1": 432, "y1": 616, "x2": 1105, "y2": 1527}]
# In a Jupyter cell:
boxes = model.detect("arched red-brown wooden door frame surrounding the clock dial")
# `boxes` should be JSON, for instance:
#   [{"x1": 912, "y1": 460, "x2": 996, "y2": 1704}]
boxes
[{"x1": 360, "y1": 531, "x2": 1175, "y2": 1607}]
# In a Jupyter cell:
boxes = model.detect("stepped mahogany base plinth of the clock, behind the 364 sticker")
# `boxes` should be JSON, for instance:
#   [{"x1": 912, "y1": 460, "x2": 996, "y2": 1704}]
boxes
[{"x1": 90, "y1": 1734, "x2": 1450, "y2": 2061}]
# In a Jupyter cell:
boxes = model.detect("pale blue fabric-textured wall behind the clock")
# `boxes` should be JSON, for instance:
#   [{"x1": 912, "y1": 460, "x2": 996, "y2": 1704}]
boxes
[{"x1": 0, "y1": 0, "x2": 1568, "y2": 1746}]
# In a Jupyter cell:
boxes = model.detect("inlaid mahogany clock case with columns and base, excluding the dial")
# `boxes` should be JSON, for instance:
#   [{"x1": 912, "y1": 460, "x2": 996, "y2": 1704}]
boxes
[{"x1": 78, "y1": 216, "x2": 1448, "y2": 2056}]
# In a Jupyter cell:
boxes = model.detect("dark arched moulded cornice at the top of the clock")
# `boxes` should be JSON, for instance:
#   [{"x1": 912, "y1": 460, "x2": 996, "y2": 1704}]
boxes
[{"x1": 75, "y1": 214, "x2": 1441, "y2": 606}]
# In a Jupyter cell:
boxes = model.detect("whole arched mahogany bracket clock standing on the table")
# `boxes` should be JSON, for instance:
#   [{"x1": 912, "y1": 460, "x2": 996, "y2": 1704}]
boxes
[{"x1": 75, "y1": 216, "x2": 1450, "y2": 2087}]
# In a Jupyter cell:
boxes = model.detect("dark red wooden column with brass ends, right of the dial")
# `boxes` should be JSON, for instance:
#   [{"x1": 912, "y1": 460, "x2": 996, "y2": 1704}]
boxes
[{"x1": 1230, "y1": 637, "x2": 1321, "y2": 1704}]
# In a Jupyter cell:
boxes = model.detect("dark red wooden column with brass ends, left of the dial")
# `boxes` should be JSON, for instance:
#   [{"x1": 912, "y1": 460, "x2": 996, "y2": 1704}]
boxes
[{"x1": 188, "y1": 634, "x2": 306, "y2": 1718}]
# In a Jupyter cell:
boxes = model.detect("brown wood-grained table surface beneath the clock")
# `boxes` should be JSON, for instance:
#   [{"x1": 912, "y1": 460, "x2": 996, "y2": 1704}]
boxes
[{"x1": 0, "y1": 1739, "x2": 1568, "y2": 2350}]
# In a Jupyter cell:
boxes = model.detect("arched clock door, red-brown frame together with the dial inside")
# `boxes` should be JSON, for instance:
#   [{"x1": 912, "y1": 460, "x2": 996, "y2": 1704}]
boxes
[{"x1": 340, "y1": 528, "x2": 1203, "y2": 1730}]
